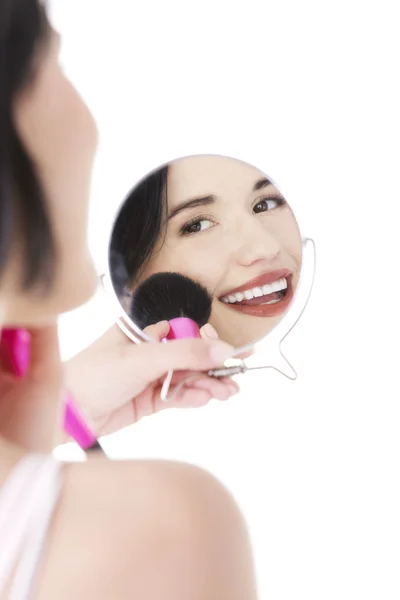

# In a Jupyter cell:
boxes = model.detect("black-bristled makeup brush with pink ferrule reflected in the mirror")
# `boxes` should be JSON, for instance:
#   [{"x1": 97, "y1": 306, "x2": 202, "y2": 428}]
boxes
[{"x1": 130, "y1": 272, "x2": 212, "y2": 340}]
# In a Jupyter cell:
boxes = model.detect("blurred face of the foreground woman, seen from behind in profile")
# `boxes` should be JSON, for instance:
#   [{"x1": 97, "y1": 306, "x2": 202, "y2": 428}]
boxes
[{"x1": 1, "y1": 24, "x2": 97, "y2": 326}]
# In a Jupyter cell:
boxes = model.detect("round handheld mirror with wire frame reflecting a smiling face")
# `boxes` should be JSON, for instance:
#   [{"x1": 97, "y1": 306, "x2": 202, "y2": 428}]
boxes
[{"x1": 103, "y1": 155, "x2": 315, "y2": 397}]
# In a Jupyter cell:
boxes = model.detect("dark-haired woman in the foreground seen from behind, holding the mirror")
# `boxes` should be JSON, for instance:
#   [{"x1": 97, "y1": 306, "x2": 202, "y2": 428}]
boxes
[{"x1": 0, "y1": 0, "x2": 255, "y2": 600}]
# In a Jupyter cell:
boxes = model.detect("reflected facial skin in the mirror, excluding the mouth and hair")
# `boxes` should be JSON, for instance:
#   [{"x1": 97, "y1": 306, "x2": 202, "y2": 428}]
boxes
[{"x1": 133, "y1": 156, "x2": 302, "y2": 347}]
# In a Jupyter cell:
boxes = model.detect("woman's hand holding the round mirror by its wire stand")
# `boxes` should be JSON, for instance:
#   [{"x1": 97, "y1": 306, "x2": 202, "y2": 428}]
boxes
[{"x1": 65, "y1": 321, "x2": 239, "y2": 436}]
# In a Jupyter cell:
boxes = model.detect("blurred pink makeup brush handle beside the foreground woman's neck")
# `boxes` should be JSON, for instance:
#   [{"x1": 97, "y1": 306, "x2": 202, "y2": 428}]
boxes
[{"x1": 0, "y1": 329, "x2": 97, "y2": 449}]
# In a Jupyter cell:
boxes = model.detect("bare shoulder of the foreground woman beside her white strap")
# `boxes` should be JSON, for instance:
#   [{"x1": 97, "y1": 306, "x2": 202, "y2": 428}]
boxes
[{"x1": 38, "y1": 458, "x2": 256, "y2": 600}]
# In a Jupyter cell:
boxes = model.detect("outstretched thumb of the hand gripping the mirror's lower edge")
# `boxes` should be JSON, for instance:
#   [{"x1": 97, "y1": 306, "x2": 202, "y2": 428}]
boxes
[{"x1": 130, "y1": 339, "x2": 235, "y2": 382}]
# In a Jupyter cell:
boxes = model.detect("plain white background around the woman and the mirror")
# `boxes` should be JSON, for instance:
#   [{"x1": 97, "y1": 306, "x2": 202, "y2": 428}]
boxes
[{"x1": 48, "y1": 0, "x2": 400, "y2": 600}]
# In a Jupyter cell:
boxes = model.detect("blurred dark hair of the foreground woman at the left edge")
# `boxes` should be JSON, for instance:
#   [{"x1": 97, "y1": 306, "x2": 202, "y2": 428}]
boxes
[{"x1": 0, "y1": 0, "x2": 55, "y2": 290}]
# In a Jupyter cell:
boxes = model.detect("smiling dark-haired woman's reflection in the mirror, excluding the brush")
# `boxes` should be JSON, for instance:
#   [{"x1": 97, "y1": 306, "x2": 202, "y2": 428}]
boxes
[{"x1": 110, "y1": 156, "x2": 302, "y2": 347}]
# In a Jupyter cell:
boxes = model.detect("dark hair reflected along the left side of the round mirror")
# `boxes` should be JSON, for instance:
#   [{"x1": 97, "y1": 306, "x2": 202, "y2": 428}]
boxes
[{"x1": 109, "y1": 165, "x2": 168, "y2": 296}]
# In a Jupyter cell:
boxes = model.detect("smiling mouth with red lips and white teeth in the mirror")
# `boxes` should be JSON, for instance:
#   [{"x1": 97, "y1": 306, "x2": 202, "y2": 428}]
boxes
[{"x1": 219, "y1": 270, "x2": 293, "y2": 317}]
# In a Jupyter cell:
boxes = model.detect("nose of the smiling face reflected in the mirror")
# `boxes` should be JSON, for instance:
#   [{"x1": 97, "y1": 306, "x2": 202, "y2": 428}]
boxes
[{"x1": 235, "y1": 216, "x2": 281, "y2": 267}]
